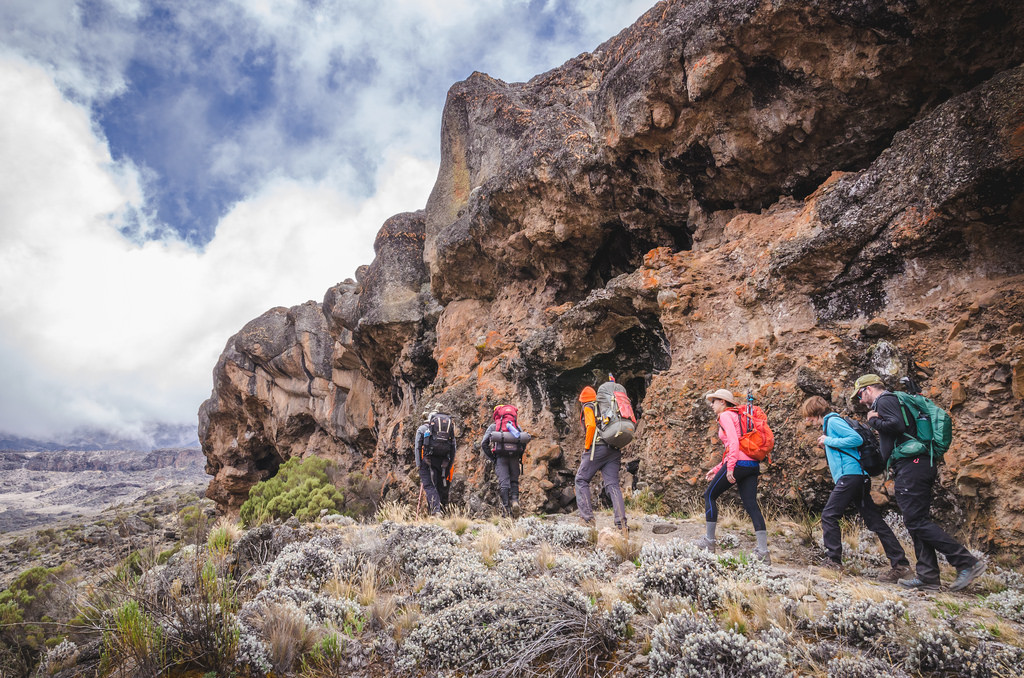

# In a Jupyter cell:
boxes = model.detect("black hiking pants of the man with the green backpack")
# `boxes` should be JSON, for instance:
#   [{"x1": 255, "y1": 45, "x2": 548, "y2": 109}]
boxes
[{"x1": 894, "y1": 456, "x2": 978, "y2": 584}]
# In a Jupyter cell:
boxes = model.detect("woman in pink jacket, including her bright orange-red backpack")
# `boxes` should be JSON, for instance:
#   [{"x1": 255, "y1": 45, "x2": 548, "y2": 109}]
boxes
[{"x1": 697, "y1": 388, "x2": 774, "y2": 564}]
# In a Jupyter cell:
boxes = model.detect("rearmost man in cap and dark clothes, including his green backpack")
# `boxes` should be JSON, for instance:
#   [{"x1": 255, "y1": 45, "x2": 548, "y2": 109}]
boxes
[{"x1": 853, "y1": 374, "x2": 985, "y2": 591}]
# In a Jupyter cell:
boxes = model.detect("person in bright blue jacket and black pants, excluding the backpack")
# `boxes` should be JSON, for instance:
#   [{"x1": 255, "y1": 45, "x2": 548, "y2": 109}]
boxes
[{"x1": 801, "y1": 395, "x2": 910, "y2": 583}]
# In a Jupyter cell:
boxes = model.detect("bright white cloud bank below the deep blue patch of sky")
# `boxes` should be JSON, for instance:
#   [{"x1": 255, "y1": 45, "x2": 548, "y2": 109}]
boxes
[{"x1": 0, "y1": 53, "x2": 435, "y2": 434}]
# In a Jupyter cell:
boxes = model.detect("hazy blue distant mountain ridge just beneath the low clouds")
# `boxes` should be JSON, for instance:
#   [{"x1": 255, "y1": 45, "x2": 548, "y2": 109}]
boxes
[{"x1": 0, "y1": 423, "x2": 200, "y2": 452}]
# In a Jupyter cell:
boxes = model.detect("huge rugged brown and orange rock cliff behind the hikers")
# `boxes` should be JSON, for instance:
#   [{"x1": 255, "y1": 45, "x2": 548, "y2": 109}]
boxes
[{"x1": 200, "y1": 0, "x2": 1024, "y2": 547}]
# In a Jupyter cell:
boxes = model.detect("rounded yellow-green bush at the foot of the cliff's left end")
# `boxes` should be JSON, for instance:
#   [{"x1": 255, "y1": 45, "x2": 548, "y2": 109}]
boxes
[{"x1": 240, "y1": 457, "x2": 345, "y2": 526}]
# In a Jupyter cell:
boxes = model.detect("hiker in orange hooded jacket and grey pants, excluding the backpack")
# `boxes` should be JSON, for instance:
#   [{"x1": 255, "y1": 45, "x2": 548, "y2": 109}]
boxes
[{"x1": 575, "y1": 386, "x2": 627, "y2": 532}]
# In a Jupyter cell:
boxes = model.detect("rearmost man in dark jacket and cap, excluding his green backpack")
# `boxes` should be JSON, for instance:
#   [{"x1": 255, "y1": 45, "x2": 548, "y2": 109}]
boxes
[{"x1": 853, "y1": 374, "x2": 985, "y2": 591}]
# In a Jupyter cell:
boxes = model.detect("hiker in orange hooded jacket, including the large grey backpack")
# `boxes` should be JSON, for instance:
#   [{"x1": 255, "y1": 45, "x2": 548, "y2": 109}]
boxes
[{"x1": 575, "y1": 375, "x2": 636, "y2": 534}]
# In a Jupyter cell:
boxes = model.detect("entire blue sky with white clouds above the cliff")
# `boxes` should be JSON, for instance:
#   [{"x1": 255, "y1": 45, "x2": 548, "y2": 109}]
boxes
[{"x1": 0, "y1": 0, "x2": 653, "y2": 438}]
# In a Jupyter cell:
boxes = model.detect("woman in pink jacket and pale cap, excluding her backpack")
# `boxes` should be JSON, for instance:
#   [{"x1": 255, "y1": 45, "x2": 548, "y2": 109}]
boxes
[{"x1": 697, "y1": 388, "x2": 771, "y2": 563}]
